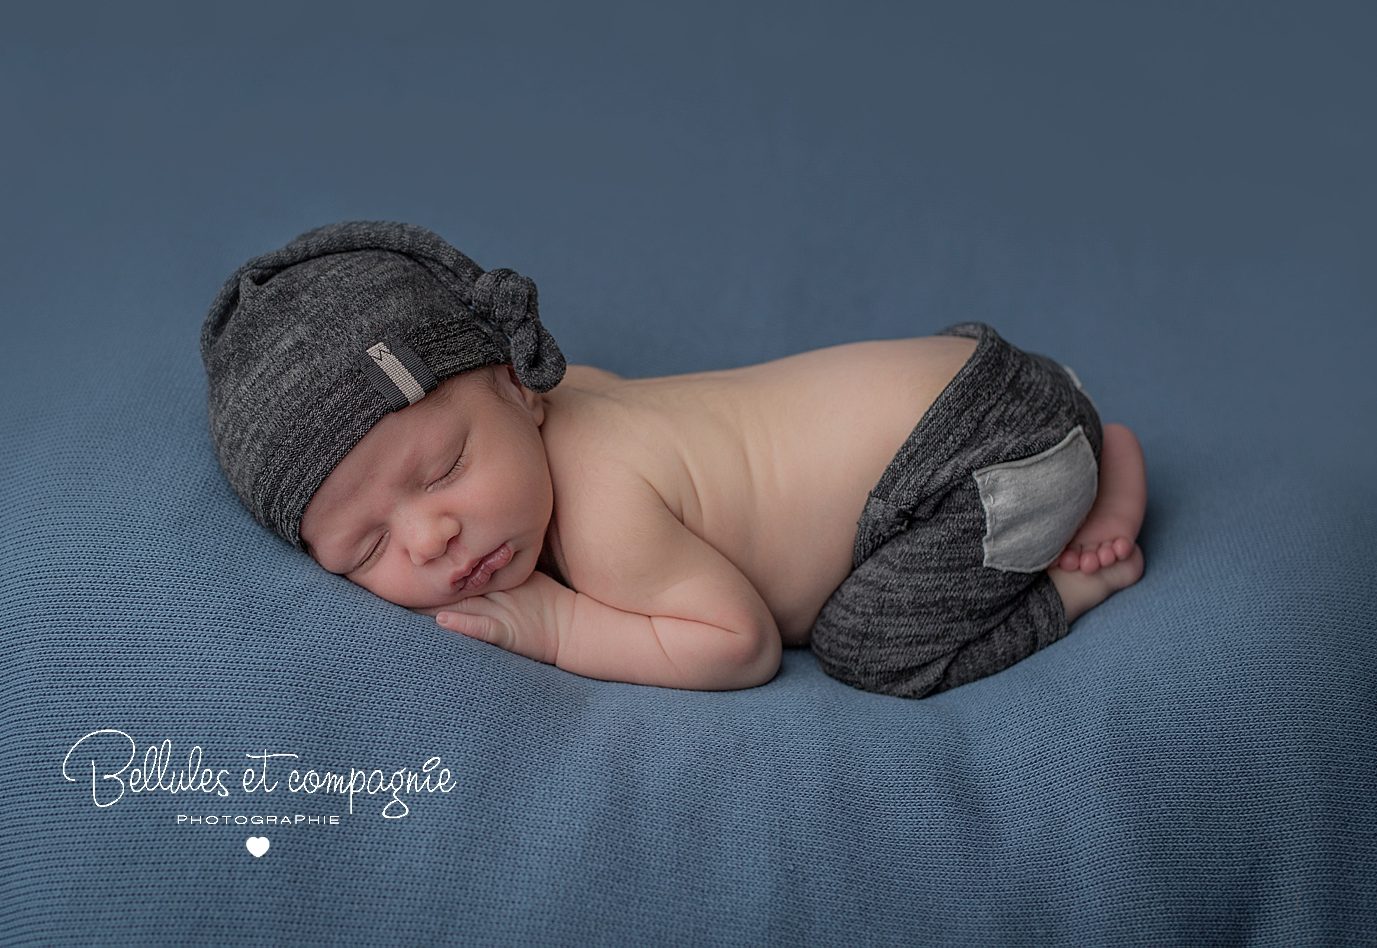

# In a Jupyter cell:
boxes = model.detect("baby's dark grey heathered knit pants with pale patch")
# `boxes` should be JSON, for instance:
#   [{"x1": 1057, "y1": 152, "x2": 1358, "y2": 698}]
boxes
[{"x1": 810, "y1": 322, "x2": 1103, "y2": 697}]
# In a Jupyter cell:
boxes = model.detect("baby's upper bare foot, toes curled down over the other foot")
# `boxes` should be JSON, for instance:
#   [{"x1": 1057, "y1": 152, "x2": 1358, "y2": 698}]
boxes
[{"x1": 1052, "y1": 424, "x2": 1147, "y2": 573}]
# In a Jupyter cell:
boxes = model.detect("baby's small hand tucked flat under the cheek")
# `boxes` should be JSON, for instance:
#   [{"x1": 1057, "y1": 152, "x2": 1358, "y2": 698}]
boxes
[{"x1": 424, "y1": 570, "x2": 573, "y2": 666}]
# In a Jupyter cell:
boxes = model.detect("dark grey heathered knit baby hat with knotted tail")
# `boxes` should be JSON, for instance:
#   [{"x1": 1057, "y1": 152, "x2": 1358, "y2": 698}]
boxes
[{"x1": 201, "y1": 220, "x2": 565, "y2": 553}]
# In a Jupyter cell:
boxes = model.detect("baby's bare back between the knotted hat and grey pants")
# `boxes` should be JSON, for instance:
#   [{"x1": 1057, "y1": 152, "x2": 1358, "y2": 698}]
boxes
[{"x1": 545, "y1": 336, "x2": 976, "y2": 646}]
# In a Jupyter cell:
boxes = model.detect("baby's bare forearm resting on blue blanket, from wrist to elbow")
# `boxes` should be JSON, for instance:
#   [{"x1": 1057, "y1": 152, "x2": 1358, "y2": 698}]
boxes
[{"x1": 555, "y1": 590, "x2": 778, "y2": 690}]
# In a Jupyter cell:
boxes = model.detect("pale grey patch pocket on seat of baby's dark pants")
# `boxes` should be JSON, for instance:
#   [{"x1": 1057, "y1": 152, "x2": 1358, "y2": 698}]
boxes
[{"x1": 974, "y1": 424, "x2": 1100, "y2": 573}]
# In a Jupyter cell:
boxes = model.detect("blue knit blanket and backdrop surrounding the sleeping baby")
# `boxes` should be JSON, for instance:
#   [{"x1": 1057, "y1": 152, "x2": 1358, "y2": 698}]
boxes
[{"x1": 0, "y1": 0, "x2": 1377, "y2": 944}]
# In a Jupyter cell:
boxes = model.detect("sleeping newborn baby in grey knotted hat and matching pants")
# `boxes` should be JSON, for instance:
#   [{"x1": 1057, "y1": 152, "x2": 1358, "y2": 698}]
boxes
[{"x1": 201, "y1": 220, "x2": 1147, "y2": 697}]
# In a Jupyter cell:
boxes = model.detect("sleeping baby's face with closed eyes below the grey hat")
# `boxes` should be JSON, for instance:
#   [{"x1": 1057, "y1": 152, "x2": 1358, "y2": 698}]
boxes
[{"x1": 302, "y1": 365, "x2": 555, "y2": 609}]
